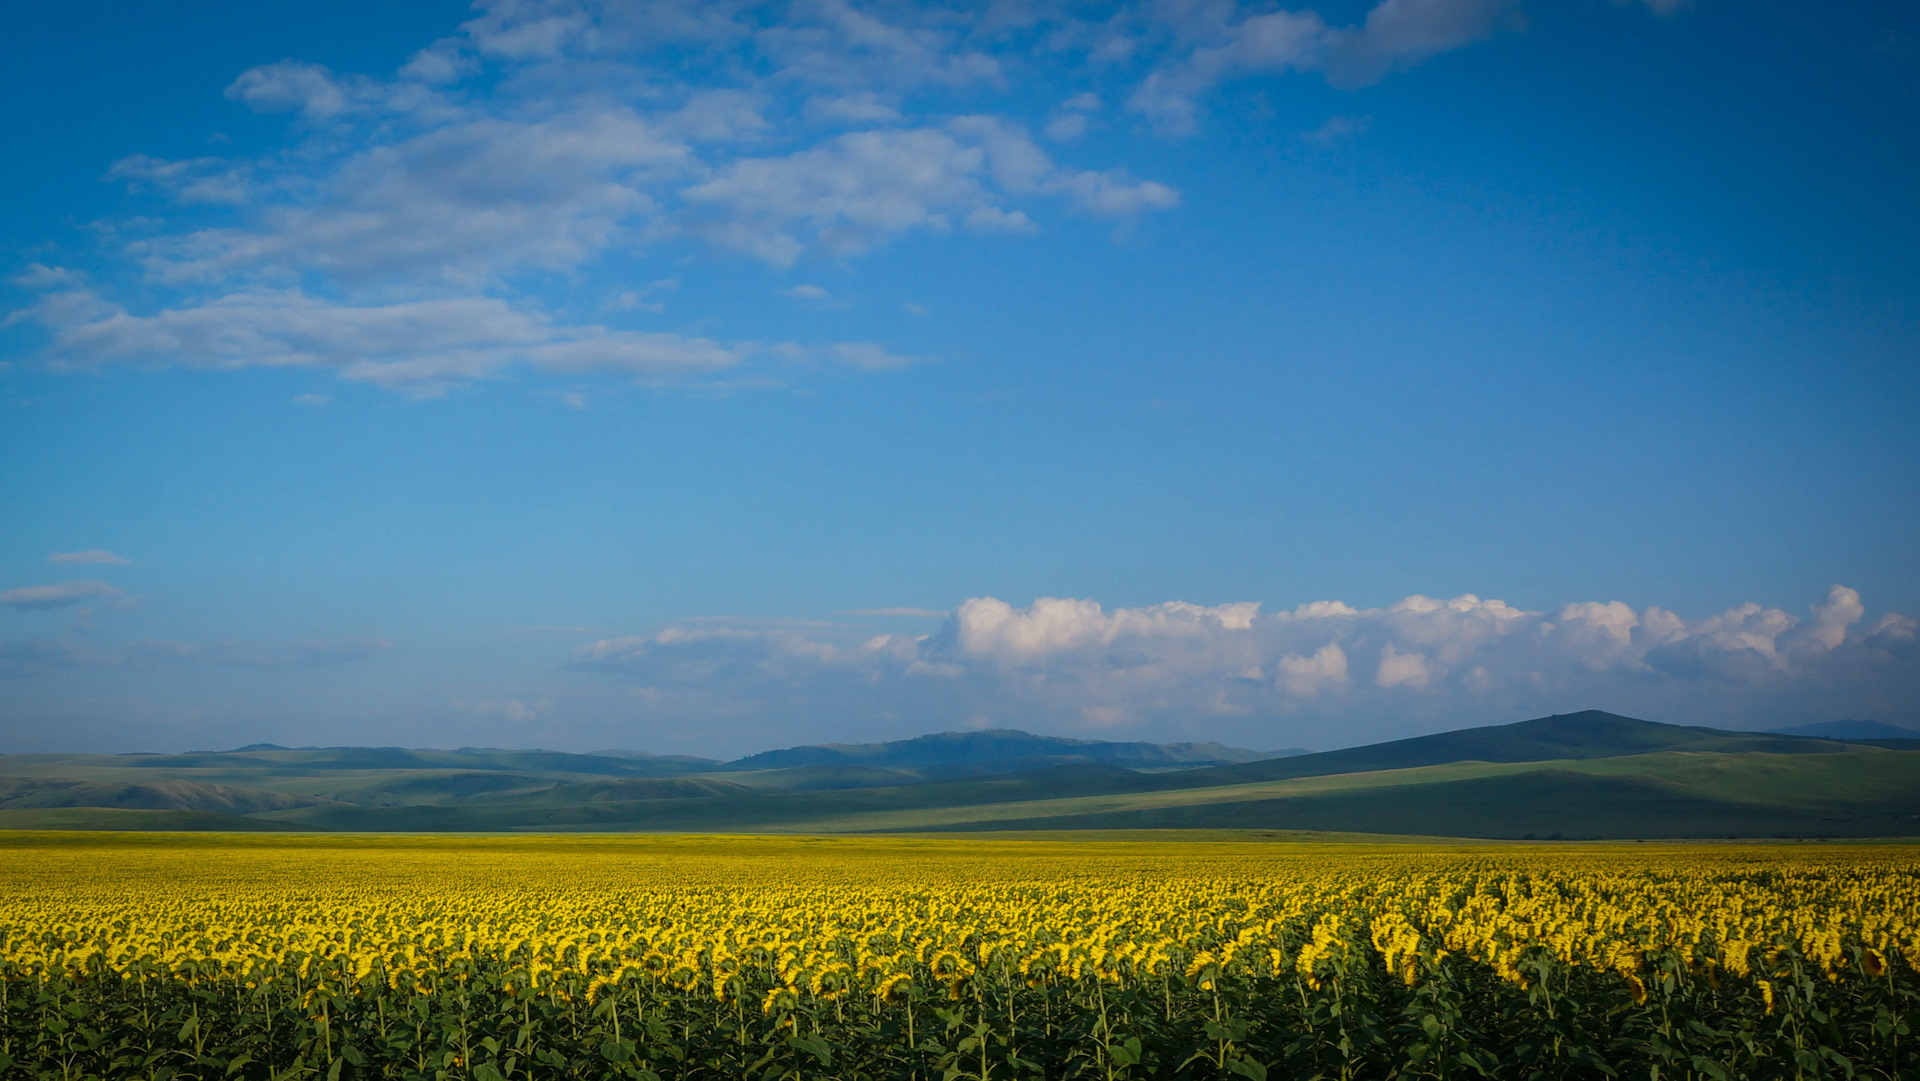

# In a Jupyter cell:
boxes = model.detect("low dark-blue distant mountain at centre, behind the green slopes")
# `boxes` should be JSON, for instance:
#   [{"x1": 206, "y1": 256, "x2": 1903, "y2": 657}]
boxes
[{"x1": 724, "y1": 728, "x2": 1265, "y2": 778}]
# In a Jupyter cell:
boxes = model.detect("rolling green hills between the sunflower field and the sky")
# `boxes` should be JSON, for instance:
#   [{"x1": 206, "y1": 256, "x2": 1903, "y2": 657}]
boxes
[{"x1": 0, "y1": 712, "x2": 1920, "y2": 839}]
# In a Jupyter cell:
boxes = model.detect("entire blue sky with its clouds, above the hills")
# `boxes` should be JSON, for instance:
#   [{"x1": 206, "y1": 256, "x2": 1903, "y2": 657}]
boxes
[{"x1": 0, "y1": 0, "x2": 1920, "y2": 755}]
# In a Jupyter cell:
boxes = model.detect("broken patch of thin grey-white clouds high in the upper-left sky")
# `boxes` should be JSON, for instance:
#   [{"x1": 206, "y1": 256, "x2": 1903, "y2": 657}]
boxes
[{"x1": 10, "y1": 0, "x2": 1676, "y2": 394}]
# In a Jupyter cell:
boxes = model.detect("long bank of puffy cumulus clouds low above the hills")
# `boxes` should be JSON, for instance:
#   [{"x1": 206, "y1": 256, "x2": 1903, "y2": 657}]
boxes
[{"x1": 570, "y1": 588, "x2": 1920, "y2": 745}]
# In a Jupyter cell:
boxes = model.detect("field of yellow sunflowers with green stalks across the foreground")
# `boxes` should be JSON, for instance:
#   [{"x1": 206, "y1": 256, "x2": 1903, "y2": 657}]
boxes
[{"x1": 0, "y1": 835, "x2": 1920, "y2": 1081}]
